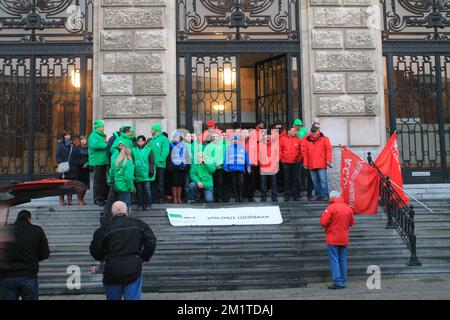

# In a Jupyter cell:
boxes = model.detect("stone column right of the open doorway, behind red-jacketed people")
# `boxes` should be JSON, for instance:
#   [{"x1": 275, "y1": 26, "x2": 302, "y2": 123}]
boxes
[{"x1": 302, "y1": 0, "x2": 386, "y2": 188}]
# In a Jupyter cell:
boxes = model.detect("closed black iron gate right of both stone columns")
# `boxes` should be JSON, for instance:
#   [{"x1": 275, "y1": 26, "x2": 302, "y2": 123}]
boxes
[{"x1": 382, "y1": 0, "x2": 450, "y2": 183}]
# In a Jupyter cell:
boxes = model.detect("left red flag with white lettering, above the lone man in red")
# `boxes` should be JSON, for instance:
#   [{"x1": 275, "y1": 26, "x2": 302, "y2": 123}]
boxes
[{"x1": 341, "y1": 147, "x2": 380, "y2": 214}]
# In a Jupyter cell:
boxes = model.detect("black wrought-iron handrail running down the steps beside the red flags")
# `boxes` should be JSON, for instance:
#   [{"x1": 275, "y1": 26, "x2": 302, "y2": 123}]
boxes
[{"x1": 367, "y1": 152, "x2": 422, "y2": 266}]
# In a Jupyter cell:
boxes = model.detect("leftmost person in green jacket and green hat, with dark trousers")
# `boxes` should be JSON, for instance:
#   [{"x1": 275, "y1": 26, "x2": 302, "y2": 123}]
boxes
[{"x1": 88, "y1": 120, "x2": 109, "y2": 206}]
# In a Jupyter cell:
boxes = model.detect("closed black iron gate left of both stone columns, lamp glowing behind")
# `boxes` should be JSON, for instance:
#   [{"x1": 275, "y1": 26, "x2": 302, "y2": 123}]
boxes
[{"x1": 0, "y1": 0, "x2": 93, "y2": 182}]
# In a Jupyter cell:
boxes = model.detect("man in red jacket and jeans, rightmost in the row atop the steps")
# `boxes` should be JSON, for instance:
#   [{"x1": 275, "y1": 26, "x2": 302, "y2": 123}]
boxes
[{"x1": 302, "y1": 125, "x2": 333, "y2": 201}]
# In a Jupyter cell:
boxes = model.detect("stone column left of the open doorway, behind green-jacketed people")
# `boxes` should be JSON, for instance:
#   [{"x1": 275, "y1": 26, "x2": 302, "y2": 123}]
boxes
[{"x1": 94, "y1": 0, "x2": 176, "y2": 136}]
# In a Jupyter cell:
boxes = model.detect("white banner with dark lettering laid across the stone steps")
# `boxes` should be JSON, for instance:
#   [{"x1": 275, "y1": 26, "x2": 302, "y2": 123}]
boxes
[{"x1": 167, "y1": 206, "x2": 283, "y2": 227}]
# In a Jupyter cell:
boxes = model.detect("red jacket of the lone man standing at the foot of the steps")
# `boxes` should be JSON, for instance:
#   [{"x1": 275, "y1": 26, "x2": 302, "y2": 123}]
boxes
[{"x1": 320, "y1": 198, "x2": 355, "y2": 246}]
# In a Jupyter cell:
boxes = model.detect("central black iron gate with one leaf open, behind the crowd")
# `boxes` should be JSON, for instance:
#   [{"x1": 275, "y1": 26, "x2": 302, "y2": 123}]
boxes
[{"x1": 178, "y1": 53, "x2": 302, "y2": 129}]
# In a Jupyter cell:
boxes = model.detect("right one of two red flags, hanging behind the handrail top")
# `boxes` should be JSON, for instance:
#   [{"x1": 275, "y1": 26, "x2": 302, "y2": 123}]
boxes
[{"x1": 375, "y1": 132, "x2": 409, "y2": 204}]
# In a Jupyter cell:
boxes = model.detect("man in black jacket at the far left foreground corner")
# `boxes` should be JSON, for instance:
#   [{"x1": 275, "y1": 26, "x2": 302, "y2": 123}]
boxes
[{"x1": 0, "y1": 210, "x2": 50, "y2": 300}]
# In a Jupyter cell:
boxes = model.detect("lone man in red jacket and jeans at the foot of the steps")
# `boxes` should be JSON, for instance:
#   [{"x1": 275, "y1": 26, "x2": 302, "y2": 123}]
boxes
[{"x1": 320, "y1": 191, "x2": 355, "y2": 289}]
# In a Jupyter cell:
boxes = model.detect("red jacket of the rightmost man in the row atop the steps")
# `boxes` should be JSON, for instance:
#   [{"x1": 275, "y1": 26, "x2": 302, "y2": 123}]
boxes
[{"x1": 302, "y1": 132, "x2": 333, "y2": 170}]
